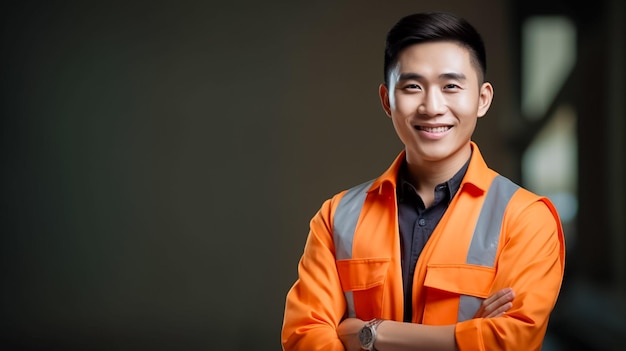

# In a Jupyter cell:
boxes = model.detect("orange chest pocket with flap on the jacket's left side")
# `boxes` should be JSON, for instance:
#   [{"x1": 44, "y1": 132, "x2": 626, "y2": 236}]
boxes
[{"x1": 337, "y1": 258, "x2": 390, "y2": 320}]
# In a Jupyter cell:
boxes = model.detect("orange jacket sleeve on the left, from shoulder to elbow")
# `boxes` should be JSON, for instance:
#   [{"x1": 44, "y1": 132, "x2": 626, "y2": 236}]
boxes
[{"x1": 281, "y1": 200, "x2": 346, "y2": 351}]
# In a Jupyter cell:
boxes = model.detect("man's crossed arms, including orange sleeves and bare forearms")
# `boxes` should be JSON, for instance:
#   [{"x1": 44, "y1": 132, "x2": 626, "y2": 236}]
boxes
[{"x1": 281, "y1": 202, "x2": 565, "y2": 351}]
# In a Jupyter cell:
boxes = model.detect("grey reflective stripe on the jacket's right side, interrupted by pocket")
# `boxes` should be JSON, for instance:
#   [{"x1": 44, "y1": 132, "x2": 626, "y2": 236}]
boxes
[{"x1": 457, "y1": 175, "x2": 519, "y2": 322}]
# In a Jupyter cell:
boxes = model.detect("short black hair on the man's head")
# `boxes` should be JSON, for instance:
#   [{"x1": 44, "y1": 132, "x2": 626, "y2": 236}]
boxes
[{"x1": 384, "y1": 12, "x2": 487, "y2": 86}]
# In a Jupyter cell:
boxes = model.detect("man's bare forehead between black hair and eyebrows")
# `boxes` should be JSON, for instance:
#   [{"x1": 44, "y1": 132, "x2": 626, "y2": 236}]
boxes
[{"x1": 396, "y1": 41, "x2": 477, "y2": 79}]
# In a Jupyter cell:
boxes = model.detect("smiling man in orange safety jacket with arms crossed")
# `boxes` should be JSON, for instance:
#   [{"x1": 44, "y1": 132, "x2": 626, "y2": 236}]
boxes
[{"x1": 282, "y1": 13, "x2": 565, "y2": 351}]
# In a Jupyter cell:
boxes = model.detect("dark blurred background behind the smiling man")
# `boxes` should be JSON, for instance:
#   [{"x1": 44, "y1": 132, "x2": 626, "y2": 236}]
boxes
[{"x1": 0, "y1": 0, "x2": 626, "y2": 350}]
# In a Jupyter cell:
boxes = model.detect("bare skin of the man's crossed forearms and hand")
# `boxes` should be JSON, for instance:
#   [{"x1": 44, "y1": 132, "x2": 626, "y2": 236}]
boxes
[{"x1": 337, "y1": 288, "x2": 515, "y2": 351}]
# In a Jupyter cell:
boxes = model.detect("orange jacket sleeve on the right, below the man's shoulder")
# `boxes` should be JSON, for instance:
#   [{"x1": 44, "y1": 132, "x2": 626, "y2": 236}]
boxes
[{"x1": 455, "y1": 198, "x2": 565, "y2": 351}]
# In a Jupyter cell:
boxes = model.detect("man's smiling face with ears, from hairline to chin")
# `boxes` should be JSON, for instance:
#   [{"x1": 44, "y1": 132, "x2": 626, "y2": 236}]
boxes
[{"x1": 380, "y1": 42, "x2": 493, "y2": 165}]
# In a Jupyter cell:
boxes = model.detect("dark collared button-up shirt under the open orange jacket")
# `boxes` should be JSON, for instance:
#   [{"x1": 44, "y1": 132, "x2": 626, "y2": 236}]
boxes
[{"x1": 396, "y1": 160, "x2": 469, "y2": 322}]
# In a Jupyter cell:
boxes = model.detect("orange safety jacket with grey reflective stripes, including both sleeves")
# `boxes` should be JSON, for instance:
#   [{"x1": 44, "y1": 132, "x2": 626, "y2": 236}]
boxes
[{"x1": 283, "y1": 143, "x2": 565, "y2": 350}]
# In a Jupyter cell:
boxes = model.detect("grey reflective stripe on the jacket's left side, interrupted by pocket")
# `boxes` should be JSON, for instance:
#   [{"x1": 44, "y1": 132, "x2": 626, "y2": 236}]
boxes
[{"x1": 333, "y1": 180, "x2": 374, "y2": 317}]
